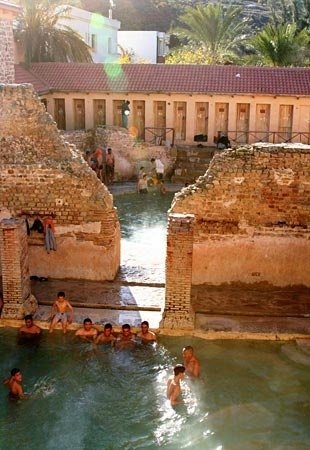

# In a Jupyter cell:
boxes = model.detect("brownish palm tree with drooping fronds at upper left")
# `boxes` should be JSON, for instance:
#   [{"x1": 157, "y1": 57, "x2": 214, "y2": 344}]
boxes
[{"x1": 14, "y1": 0, "x2": 92, "y2": 64}]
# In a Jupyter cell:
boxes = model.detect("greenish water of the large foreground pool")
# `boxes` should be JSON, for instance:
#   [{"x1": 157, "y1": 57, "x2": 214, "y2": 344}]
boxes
[{"x1": 0, "y1": 329, "x2": 310, "y2": 450}]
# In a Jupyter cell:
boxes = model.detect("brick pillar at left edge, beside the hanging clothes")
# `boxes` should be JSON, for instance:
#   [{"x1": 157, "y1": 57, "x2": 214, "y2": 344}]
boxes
[{"x1": 0, "y1": 218, "x2": 37, "y2": 319}]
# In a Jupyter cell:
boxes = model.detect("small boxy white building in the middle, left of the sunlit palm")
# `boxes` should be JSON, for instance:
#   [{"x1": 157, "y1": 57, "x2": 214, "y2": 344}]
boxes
[{"x1": 118, "y1": 31, "x2": 170, "y2": 64}]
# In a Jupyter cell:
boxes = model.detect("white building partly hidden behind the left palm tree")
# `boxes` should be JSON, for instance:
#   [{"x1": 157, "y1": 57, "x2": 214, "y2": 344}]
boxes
[{"x1": 58, "y1": 5, "x2": 121, "y2": 63}]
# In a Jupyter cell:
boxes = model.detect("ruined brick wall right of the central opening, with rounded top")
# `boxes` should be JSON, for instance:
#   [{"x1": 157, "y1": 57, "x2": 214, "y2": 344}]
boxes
[{"x1": 172, "y1": 144, "x2": 310, "y2": 286}]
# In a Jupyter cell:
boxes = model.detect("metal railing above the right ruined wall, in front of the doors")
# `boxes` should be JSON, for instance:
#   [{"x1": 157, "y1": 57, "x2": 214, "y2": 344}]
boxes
[{"x1": 227, "y1": 131, "x2": 310, "y2": 145}]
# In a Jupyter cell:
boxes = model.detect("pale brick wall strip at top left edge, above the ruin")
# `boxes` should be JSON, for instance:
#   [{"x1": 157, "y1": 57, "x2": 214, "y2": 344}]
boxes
[{"x1": 0, "y1": 18, "x2": 15, "y2": 83}]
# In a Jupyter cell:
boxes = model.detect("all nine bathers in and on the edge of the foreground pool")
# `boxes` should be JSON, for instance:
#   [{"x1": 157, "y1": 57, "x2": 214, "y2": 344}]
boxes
[{"x1": 3, "y1": 291, "x2": 200, "y2": 406}]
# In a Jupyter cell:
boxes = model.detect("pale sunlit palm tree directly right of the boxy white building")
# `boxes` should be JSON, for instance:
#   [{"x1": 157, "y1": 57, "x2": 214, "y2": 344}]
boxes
[{"x1": 173, "y1": 3, "x2": 251, "y2": 64}]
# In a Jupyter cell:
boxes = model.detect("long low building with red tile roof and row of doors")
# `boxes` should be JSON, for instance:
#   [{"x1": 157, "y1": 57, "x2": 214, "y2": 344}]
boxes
[{"x1": 16, "y1": 63, "x2": 310, "y2": 145}]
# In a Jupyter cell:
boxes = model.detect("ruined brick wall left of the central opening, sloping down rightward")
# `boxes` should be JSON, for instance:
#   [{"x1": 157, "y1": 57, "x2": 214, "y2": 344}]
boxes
[{"x1": 0, "y1": 85, "x2": 120, "y2": 280}]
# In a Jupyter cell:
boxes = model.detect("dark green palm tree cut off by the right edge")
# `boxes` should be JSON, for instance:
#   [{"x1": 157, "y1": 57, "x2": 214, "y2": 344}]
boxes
[{"x1": 252, "y1": 24, "x2": 310, "y2": 66}]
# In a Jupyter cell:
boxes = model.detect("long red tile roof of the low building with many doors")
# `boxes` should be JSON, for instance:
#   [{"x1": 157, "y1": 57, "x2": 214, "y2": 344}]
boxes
[{"x1": 16, "y1": 63, "x2": 310, "y2": 96}]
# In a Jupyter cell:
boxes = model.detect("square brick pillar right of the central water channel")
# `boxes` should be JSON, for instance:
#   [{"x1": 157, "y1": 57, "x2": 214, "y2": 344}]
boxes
[{"x1": 161, "y1": 213, "x2": 195, "y2": 329}]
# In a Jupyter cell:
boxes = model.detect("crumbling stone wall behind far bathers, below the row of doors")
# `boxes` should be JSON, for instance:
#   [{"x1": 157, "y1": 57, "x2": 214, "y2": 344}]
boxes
[{"x1": 61, "y1": 126, "x2": 176, "y2": 181}]
